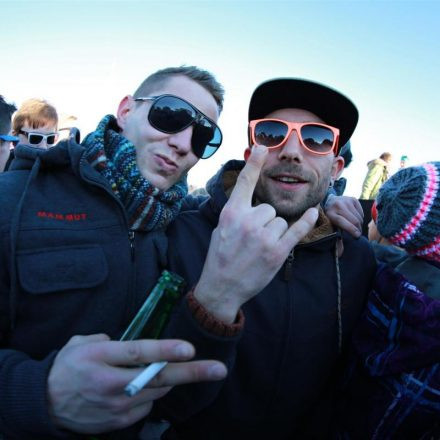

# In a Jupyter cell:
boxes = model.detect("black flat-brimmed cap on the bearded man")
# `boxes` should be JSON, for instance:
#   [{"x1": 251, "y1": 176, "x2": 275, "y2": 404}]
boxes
[{"x1": 249, "y1": 78, "x2": 359, "y2": 153}]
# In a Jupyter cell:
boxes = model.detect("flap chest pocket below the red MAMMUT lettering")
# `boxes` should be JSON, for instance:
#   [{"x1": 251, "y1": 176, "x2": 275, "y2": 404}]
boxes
[{"x1": 17, "y1": 245, "x2": 108, "y2": 295}]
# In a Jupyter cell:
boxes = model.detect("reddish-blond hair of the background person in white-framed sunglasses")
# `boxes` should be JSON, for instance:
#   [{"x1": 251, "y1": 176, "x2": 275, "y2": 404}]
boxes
[{"x1": 12, "y1": 98, "x2": 58, "y2": 136}]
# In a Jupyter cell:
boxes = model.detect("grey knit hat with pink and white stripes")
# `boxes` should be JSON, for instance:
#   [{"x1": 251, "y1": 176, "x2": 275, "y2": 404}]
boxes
[{"x1": 376, "y1": 162, "x2": 440, "y2": 261}]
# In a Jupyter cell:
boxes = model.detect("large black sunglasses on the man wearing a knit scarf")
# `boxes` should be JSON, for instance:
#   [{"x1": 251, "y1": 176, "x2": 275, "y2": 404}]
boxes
[{"x1": 135, "y1": 95, "x2": 223, "y2": 159}]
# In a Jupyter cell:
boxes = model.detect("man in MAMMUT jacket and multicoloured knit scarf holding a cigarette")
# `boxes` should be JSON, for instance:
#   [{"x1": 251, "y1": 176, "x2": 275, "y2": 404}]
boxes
[{"x1": 0, "y1": 67, "x2": 226, "y2": 440}]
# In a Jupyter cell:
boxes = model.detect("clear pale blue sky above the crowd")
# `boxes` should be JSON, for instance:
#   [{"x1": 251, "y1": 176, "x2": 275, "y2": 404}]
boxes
[{"x1": 0, "y1": 0, "x2": 440, "y2": 196}]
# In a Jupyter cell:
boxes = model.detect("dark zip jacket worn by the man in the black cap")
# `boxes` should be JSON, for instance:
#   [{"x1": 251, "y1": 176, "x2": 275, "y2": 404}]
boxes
[{"x1": 156, "y1": 161, "x2": 375, "y2": 440}]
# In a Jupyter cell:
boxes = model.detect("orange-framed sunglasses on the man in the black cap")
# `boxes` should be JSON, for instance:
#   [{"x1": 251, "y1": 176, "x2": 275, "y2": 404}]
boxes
[{"x1": 249, "y1": 119, "x2": 339, "y2": 155}]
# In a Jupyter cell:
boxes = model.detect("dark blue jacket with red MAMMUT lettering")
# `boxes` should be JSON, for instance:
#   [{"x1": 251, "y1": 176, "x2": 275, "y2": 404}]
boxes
[{"x1": 0, "y1": 139, "x2": 166, "y2": 440}]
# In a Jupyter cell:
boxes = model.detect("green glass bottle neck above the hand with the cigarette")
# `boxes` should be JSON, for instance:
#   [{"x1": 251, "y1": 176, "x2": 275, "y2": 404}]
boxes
[{"x1": 121, "y1": 270, "x2": 185, "y2": 341}]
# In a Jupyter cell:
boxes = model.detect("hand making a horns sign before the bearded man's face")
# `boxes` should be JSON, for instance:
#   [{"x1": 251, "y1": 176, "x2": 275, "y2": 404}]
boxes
[{"x1": 194, "y1": 146, "x2": 318, "y2": 323}]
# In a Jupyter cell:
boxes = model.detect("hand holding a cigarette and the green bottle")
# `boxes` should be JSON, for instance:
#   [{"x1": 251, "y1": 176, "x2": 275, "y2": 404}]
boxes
[{"x1": 48, "y1": 335, "x2": 226, "y2": 434}]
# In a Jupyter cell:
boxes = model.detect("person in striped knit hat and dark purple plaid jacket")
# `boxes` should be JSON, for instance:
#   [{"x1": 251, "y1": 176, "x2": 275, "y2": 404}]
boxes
[{"x1": 339, "y1": 162, "x2": 440, "y2": 440}]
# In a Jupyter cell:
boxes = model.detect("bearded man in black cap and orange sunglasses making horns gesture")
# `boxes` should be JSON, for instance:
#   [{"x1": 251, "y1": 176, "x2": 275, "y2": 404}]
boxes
[{"x1": 158, "y1": 78, "x2": 376, "y2": 440}]
